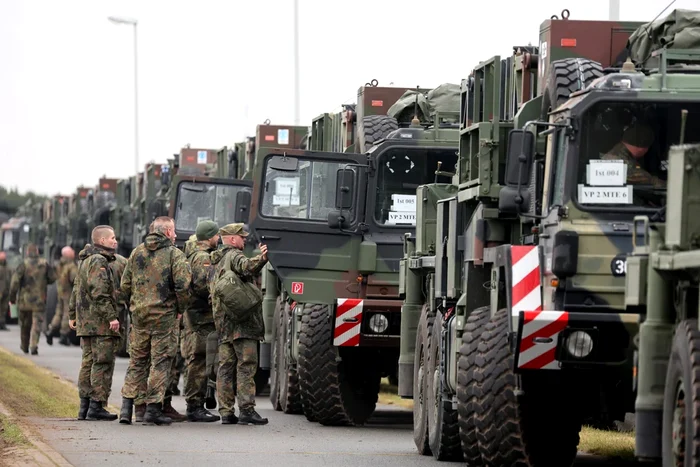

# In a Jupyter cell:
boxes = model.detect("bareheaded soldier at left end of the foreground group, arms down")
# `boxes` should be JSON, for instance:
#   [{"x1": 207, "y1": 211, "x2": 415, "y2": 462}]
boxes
[{"x1": 64, "y1": 225, "x2": 120, "y2": 421}]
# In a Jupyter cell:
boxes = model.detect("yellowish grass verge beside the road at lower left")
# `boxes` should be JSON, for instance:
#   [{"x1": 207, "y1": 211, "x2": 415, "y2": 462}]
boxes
[{"x1": 0, "y1": 350, "x2": 79, "y2": 418}]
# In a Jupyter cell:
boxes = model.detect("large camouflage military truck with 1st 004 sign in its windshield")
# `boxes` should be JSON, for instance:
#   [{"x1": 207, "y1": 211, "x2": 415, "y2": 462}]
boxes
[{"x1": 399, "y1": 12, "x2": 698, "y2": 466}]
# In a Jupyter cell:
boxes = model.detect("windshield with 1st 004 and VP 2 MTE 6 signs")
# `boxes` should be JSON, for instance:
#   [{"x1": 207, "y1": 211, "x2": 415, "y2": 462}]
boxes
[{"x1": 576, "y1": 101, "x2": 700, "y2": 209}]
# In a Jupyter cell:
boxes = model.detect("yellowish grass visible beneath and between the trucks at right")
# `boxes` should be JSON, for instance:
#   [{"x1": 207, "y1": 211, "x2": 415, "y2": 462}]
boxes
[{"x1": 379, "y1": 378, "x2": 634, "y2": 460}]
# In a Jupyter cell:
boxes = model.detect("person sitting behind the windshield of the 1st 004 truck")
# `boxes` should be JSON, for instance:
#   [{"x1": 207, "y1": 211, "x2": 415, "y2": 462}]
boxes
[{"x1": 603, "y1": 120, "x2": 666, "y2": 188}]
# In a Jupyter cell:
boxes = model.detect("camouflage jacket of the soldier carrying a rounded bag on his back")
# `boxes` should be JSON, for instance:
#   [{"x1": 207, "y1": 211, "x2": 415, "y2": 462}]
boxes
[{"x1": 209, "y1": 245, "x2": 267, "y2": 342}]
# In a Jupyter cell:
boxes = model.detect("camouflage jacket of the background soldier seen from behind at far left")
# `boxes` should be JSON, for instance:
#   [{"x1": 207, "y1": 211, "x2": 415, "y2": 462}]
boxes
[{"x1": 9, "y1": 250, "x2": 56, "y2": 311}]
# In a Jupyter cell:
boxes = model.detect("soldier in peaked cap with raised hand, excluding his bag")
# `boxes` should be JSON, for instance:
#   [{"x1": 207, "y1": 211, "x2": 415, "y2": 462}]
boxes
[{"x1": 211, "y1": 224, "x2": 267, "y2": 425}]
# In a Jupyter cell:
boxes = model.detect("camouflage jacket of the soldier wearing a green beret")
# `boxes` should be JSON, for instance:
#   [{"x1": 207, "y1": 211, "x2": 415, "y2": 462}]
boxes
[{"x1": 185, "y1": 240, "x2": 214, "y2": 328}]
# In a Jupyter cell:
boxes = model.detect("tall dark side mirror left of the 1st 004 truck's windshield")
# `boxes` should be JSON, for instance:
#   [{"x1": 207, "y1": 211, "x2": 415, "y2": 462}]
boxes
[{"x1": 498, "y1": 130, "x2": 535, "y2": 213}]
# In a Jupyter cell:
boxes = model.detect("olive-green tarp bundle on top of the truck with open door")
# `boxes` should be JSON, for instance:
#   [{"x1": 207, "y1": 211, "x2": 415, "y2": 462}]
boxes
[{"x1": 387, "y1": 83, "x2": 459, "y2": 123}]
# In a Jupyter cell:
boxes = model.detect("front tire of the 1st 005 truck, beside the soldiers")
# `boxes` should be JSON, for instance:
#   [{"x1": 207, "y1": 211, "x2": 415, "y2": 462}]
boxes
[{"x1": 299, "y1": 305, "x2": 381, "y2": 425}]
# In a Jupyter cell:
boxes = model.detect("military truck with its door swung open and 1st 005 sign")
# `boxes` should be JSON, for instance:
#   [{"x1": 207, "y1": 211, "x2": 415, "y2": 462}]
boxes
[{"x1": 251, "y1": 81, "x2": 459, "y2": 425}]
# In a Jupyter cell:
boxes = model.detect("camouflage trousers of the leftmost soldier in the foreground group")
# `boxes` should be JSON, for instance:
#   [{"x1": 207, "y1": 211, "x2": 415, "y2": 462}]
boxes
[{"x1": 78, "y1": 336, "x2": 120, "y2": 402}]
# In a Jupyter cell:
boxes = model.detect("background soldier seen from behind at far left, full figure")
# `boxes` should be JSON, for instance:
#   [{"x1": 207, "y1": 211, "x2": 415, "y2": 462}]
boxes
[{"x1": 10, "y1": 243, "x2": 56, "y2": 355}]
